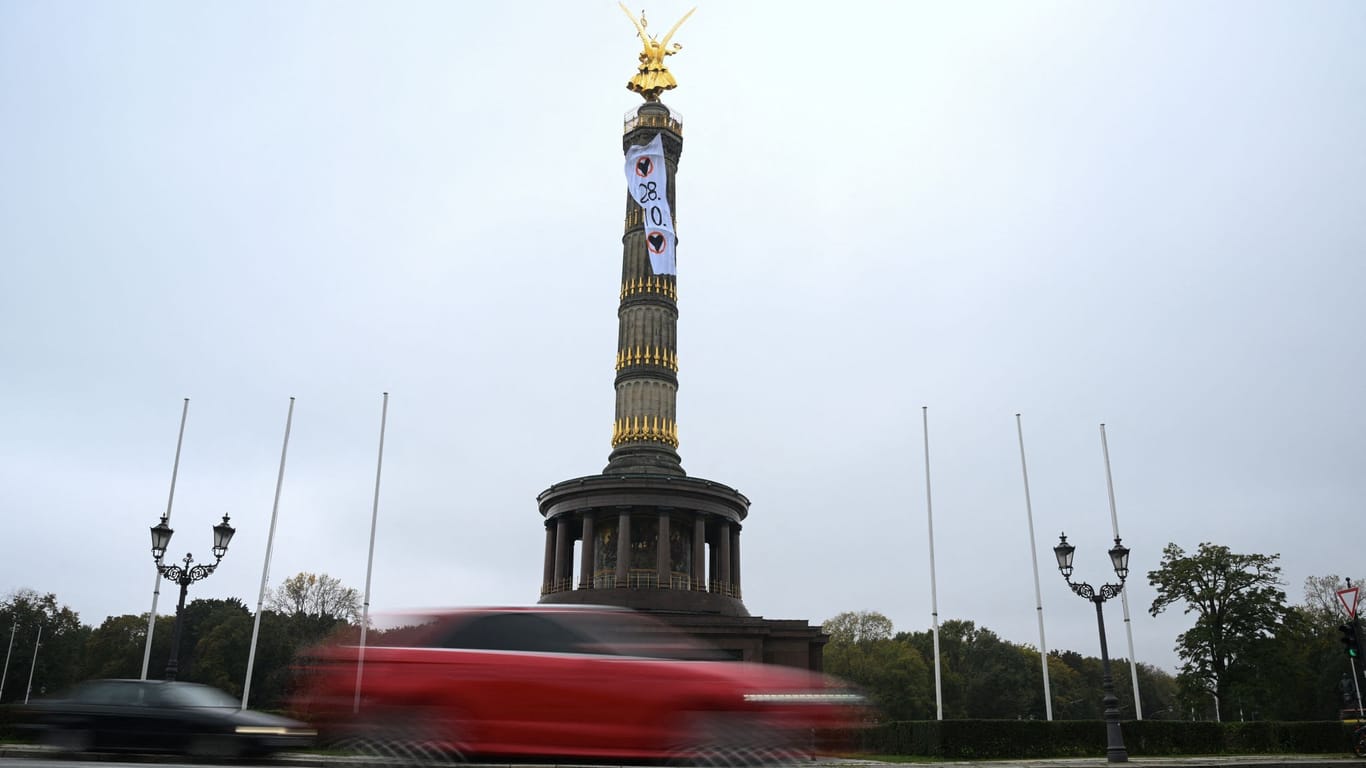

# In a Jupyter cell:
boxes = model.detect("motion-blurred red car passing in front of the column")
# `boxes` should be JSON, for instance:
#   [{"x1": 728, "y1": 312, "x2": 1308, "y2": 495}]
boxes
[{"x1": 294, "y1": 607, "x2": 865, "y2": 763}]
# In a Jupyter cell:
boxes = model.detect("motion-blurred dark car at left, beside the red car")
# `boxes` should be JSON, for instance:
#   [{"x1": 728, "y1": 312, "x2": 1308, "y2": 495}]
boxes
[{"x1": 20, "y1": 681, "x2": 316, "y2": 757}]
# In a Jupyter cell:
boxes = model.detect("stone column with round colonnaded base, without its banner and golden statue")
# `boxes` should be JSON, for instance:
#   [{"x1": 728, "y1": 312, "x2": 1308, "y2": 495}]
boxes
[{"x1": 537, "y1": 101, "x2": 826, "y2": 670}]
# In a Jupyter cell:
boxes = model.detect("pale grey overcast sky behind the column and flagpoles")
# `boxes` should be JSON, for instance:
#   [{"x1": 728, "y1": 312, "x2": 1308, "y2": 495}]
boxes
[{"x1": 0, "y1": 0, "x2": 1366, "y2": 670}]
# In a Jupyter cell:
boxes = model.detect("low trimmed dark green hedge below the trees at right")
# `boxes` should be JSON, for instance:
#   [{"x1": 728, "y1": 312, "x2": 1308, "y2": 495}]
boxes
[{"x1": 822, "y1": 720, "x2": 1354, "y2": 760}]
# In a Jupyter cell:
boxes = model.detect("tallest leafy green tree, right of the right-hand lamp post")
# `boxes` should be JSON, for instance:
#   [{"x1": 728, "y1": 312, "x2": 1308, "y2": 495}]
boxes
[{"x1": 1147, "y1": 543, "x2": 1285, "y2": 704}]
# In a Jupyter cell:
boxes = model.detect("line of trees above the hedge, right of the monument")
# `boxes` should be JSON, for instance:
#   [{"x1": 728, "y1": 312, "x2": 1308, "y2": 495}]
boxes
[{"x1": 824, "y1": 543, "x2": 1366, "y2": 722}]
